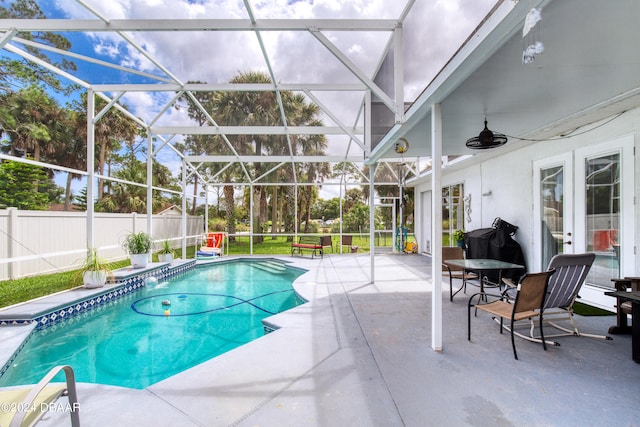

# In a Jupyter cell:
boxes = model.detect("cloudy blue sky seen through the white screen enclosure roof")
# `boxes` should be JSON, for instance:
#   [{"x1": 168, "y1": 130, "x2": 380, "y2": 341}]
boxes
[{"x1": 41, "y1": 0, "x2": 497, "y2": 199}]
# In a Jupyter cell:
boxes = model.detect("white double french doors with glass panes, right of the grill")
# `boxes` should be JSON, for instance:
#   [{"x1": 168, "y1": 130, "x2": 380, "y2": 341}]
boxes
[{"x1": 534, "y1": 136, "x2": 635, "y2": 309}]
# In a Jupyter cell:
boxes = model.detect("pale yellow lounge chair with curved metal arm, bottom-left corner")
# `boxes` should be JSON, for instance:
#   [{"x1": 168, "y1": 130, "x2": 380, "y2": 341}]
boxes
[{"x1": 0, "y1": 365, "x2": 80, "y2": 427}]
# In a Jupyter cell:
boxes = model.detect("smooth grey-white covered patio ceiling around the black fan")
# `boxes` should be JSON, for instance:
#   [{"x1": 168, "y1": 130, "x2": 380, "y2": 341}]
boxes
[{"x1": 372, "y1": 0, "x2": 640, "y2": 166}]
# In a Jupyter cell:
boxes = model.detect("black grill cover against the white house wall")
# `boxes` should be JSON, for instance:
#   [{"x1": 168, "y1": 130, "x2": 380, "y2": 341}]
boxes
[{"x1": 464, "y1": 218, "x2": 526, "y2": 283}]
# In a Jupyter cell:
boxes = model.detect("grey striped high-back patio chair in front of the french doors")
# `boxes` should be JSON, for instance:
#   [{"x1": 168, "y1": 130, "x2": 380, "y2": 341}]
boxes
[{"x1": 505, "y1": 252, "x2": 611, "y2": 344}]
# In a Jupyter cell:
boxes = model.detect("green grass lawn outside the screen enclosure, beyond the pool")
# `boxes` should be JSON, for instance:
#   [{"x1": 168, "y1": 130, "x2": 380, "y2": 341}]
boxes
[{"x1": 0, "y1": 236, "x2": 384, "y2": 308}]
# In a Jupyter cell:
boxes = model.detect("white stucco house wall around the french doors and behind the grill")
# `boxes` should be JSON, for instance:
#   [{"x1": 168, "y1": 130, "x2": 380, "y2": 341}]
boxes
[{"x1": 408, "y1": 109, "x2": 640, "y2": 275}]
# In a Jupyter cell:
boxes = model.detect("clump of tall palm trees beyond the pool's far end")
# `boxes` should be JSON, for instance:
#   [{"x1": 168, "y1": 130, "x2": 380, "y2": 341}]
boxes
[{"x1": 208, "y1": 72, "x2": 329, "y2": 242}]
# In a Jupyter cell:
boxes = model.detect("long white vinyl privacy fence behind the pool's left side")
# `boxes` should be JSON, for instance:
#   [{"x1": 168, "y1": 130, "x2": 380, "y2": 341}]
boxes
[{"x1": 0, "y1": 208, "x2": 204, "y2": 280}]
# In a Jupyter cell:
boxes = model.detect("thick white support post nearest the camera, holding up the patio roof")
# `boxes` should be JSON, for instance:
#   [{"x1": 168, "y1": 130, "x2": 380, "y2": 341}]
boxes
[{"x1": 431, "y1": 104, "x2": 442, "y2": 351}]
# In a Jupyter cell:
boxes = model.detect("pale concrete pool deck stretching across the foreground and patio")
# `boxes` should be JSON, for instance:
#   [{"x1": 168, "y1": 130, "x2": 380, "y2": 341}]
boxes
[{"x1": 1, "y1": 254, "x2": 640, "y2": 427}]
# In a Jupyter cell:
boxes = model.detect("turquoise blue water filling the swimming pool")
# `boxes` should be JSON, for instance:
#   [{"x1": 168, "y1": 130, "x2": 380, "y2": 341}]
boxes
[{"x1": 0, "y1": 260, "x2": 303, "y2": 389}]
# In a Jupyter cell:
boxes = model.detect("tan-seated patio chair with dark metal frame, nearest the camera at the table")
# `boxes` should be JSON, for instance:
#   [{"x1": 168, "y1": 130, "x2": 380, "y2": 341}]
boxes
[{"x1": 467, "y1": 270, "x2": 555, "y2": 360}]
